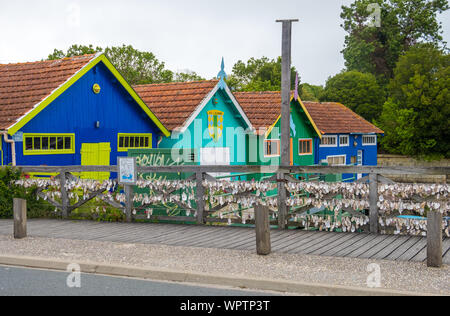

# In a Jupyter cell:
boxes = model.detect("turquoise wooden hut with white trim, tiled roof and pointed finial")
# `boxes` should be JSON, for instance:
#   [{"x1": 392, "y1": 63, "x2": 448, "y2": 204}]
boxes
[{"x1": 134, "y1": 64, "x2": 254, "y2": 173}]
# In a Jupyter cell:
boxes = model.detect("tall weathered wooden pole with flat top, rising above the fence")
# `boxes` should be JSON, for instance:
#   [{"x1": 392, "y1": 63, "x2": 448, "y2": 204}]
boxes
[{"x1": 276, "y1": 19, "x2": 298, "y2": 229}]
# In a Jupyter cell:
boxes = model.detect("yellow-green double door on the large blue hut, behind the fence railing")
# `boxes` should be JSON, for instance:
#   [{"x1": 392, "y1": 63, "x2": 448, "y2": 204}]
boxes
[{"x1": 81, "y1": 143, "x2": 111, "y2": 180}]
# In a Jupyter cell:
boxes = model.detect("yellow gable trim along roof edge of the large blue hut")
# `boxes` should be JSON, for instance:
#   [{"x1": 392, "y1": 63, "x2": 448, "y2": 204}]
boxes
[{"x1": 8, "y1": 54, "x2": 170, "y2": 137}]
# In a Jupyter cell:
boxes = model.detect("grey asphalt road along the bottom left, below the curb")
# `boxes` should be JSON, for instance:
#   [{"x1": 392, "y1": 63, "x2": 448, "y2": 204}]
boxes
[{"x1": 0, "y1": 266, "x2": 273, "y2": 296}]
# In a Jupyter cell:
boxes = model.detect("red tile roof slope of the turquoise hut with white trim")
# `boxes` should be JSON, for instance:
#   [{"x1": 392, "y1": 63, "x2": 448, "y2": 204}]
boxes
[{"x1": 133, "y1": 80, "x2": 219, "y2": 130}]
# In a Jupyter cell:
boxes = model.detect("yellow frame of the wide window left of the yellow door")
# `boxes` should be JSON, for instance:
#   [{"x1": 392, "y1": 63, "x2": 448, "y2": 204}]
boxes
[{"x1": 23, "y1": 133, "x2": 75, "y2": 156}]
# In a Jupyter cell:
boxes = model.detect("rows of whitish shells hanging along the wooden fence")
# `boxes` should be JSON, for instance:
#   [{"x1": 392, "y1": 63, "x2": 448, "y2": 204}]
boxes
[{"x1": 14, "y1": 177, "x2": 450, "y2": 237}]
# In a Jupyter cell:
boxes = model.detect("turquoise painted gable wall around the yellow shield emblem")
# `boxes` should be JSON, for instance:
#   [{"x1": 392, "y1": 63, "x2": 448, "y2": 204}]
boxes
[{"x1": 159, "y1": 89, "x2": 248, "y2": 165}]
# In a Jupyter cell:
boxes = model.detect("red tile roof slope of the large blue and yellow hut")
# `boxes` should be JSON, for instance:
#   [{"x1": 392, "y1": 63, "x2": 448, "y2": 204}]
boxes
[{"x1": 0, "y1": 55, "x2": 96, "y2": 130}]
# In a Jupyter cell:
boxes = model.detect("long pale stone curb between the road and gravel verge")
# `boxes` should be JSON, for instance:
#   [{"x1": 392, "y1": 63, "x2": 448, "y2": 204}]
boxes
[{"x1": 0, "y1": 256, "x2": 435, "y2": 296}]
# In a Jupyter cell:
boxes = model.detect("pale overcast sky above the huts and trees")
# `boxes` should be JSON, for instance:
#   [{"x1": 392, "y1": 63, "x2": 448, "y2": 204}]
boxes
[{"x1": 0, "y1": 0, "x2": 450, "y2": 84}]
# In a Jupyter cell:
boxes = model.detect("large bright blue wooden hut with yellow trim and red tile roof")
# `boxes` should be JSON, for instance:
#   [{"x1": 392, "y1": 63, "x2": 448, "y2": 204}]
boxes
[{"x1": 0, "y1": 54, "x2": 170, "y2": 179}]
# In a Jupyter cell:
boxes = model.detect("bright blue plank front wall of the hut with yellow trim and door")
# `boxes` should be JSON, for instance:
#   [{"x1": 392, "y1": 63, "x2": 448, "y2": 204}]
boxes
[{"x1": 4, "y1": 62, "x2": 160, "y2": 166}]
